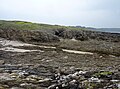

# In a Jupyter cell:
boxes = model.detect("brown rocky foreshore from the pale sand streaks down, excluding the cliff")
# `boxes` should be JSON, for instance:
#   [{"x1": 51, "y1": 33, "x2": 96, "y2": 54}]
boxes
[{"x1": 0, "y1": 38, "x2": 120, "y2": 89}]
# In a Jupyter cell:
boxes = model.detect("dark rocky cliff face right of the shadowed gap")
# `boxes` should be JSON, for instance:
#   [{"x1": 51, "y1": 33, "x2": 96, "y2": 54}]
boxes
[{"x1": 56, "y1": 30, "x2": 120, "y2": 42}]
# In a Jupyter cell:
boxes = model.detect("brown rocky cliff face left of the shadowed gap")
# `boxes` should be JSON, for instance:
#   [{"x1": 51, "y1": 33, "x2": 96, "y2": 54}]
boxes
[{"x1": 0, "y1": 29, "x2": 59, "y2": 42}]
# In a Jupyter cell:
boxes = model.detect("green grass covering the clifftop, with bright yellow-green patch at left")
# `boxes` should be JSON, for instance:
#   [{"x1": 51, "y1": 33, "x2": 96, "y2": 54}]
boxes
[{"x1": 0, "y1": 20, "x2": 84, "y2": 30}]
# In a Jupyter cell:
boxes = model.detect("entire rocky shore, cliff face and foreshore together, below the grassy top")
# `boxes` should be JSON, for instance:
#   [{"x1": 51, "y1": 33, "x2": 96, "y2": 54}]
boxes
[{"x1": 0, "y1": 21, "x2": 120, "y2": 89}]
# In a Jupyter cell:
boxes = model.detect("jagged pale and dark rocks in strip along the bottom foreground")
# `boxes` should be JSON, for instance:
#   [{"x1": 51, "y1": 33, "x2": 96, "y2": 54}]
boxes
[{"x1": 0, "y1": 64, "x2": 120, "y2": 89}]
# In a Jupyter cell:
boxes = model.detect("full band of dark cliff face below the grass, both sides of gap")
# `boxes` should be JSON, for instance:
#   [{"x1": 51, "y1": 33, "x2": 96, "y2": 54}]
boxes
[{"x1": 0, "y1": 29, "x2": 120, "y2": 42}]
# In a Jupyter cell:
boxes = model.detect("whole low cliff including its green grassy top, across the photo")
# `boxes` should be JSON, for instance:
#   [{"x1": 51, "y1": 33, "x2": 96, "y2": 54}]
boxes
[{"x1": 0, "y1": 21, "x2": 120, "y2": 42}]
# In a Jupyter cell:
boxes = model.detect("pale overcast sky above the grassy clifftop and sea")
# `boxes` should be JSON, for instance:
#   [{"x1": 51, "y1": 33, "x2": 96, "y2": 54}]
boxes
[{"x1": 0, "y1": 0, "x2": 120, "y2": 27}]
